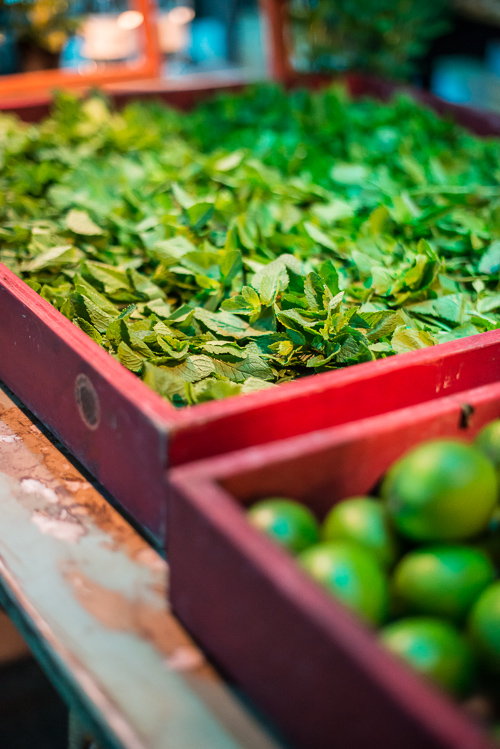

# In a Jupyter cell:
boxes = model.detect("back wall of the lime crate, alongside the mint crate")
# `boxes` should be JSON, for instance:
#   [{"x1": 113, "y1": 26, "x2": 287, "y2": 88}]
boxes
[{"x1": 218, "y1": 383, "x2": 500, "y2": 517}]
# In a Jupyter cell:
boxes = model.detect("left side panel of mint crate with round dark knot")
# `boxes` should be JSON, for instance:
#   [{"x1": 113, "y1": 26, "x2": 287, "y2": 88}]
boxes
[{"x1": 0, "y1": 266, "x2": 173, "y2": 538}]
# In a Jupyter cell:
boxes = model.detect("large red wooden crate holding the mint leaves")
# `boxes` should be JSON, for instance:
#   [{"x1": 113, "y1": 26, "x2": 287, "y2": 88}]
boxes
[{"x1": 0, "y1": 77, "x2": 500, "y2": 538}]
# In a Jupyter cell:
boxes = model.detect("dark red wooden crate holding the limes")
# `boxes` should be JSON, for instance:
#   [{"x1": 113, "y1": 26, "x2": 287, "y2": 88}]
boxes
[{"x1": 167, "y1": 383, "x2": 500, "y2": 749}]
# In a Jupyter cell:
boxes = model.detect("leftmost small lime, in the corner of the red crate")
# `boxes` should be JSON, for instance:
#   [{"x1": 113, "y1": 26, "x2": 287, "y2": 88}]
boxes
[{"x1": 248, "y1": 497, "x2": 319, "y2": 554}]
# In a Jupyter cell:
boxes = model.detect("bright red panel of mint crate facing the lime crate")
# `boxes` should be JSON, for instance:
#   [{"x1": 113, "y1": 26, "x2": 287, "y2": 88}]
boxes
[{"x1": 170, "y1": 331, "x2": 500, "y2": 465}]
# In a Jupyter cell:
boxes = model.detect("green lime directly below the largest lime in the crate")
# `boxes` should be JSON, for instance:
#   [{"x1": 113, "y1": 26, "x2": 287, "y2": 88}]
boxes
[{"x1": 392, "y1": 546, "x2": 495, "y2": 621}]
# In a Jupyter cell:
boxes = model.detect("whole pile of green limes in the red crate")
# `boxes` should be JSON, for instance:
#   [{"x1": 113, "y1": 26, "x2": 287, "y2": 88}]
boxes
[{"x1": 248, "y1": 419, "x2": 500, "y2": 720}]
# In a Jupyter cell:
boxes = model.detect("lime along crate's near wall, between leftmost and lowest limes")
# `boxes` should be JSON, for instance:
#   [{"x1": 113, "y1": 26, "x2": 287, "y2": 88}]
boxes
[{"x1": 298, "y1": 541, "x2": 388, "y2": 624}]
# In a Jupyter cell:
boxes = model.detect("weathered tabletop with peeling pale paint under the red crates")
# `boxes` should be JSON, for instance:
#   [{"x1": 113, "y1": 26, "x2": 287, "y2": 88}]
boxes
[{"x1": 0, "y1": 387, "x2": 277, "y2": 749}]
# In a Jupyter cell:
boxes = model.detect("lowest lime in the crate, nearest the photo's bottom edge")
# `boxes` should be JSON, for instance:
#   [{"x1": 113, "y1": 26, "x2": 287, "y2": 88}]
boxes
[{"x1": 380, "y1": 617, "x2": 474, "y2": 696}]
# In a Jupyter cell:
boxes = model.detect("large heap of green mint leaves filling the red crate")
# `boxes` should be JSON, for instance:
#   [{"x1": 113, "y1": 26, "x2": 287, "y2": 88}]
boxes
[{"x1": 0, "y1": 84, "x2": 500, "y2": 406}]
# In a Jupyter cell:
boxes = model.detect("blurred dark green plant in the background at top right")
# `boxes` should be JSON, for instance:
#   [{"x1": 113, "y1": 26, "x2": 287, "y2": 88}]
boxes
[{"x1": 288, "y1": 0, "x2": 449, "y2": 78}]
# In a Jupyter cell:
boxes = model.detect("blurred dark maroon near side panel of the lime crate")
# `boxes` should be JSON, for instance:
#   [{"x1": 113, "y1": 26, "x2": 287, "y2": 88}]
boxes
[{"x1": 168, "y1": 479, "x2": 489, "y2": 749}]
